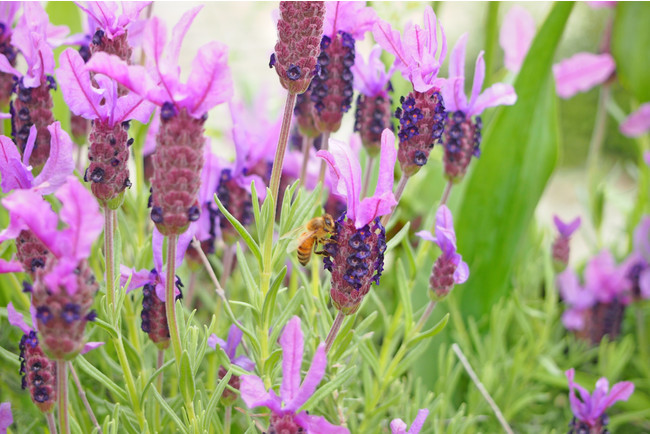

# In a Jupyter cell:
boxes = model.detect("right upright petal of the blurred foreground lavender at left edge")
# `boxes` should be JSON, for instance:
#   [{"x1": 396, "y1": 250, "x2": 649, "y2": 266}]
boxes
[{"x1": 55, "y1": 176, "x2": 104, "y2": 260}]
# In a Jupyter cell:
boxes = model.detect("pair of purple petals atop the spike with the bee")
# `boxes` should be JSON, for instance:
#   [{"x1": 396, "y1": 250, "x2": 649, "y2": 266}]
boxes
[{"x1": 316, "y1": 129, "x2": 397, "y2": 229}]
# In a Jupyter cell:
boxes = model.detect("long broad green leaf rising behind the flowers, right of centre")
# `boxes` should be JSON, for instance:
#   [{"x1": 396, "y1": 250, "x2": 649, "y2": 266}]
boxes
[{"x1": 452, "y1": 3, "x2": 573, "y2": 317}]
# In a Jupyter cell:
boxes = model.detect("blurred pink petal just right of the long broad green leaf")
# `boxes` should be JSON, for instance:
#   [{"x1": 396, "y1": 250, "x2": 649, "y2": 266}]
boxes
[{"x1": 553, "y1": 53, "x2": 616, "y2": 99}]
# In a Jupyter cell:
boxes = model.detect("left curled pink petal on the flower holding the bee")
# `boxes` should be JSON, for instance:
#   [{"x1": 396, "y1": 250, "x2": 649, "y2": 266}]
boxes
[{"x1": 316, "y1": 139, "x2": 361, "y2": 219}]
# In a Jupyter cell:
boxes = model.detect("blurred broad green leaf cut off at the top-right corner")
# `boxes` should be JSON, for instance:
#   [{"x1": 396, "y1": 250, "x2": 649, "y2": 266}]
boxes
[{"x1": 611, "y1": 2, "x2": 650, "y2": 102}]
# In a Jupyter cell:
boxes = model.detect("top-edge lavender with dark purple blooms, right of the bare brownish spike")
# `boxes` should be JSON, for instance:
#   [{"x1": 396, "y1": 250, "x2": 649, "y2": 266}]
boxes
[{"x1": 310, "y1": 1, "x2": 377, "y2": 133}]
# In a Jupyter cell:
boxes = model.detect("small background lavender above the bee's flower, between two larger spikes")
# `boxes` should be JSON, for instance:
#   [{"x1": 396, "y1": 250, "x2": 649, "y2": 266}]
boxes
[{"x1": 352, "y1": 45, "x2": 393, "y2": 157}]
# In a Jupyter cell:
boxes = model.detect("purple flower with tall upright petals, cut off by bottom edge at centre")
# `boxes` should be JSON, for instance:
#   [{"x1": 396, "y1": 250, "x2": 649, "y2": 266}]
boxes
[{"x1": 241, "y1": 316, "x2": 349, "y2": 434}]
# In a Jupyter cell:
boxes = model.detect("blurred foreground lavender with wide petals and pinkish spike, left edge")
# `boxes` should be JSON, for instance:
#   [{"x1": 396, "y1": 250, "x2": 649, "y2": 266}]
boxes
[{"x1": 0, "y1": 176, "x2": 103, "y2": 359}]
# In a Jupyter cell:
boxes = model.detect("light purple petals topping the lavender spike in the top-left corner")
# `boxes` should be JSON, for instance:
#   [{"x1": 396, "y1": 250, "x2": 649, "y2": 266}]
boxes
[{"x1": 0, "y1": 2, "x2": 68, "y2": 88}]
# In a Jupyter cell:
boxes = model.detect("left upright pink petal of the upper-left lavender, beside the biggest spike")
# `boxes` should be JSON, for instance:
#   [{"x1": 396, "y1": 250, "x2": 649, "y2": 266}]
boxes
[{"x1": 56, "y1": 48, "x2": 104, "y2": 119}]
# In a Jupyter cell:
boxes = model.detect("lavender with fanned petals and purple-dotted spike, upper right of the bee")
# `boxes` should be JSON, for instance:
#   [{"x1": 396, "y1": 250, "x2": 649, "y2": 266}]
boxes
[{"x1": 372, "y1": 6, "x2": 447, "y2": 176}]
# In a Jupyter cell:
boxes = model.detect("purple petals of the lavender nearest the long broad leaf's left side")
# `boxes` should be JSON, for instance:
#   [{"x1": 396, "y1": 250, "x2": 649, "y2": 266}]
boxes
[{"x1": 442, "y1": 33, "x2": 517, "y2": 116}]
